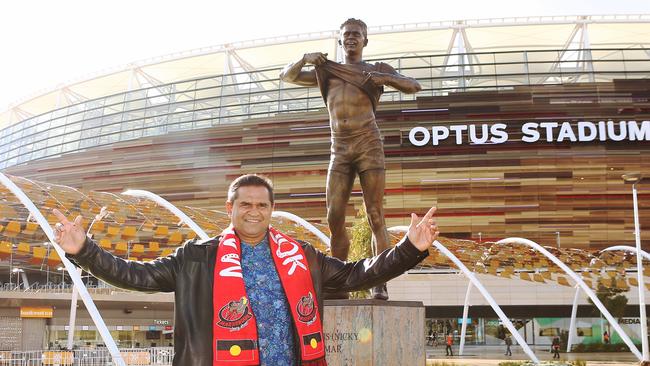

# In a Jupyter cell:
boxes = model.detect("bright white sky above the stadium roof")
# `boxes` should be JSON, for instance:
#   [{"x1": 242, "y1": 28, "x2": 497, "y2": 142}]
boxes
[{"x1": 0, "y1": 0, "x2": 650, "y2": 111}]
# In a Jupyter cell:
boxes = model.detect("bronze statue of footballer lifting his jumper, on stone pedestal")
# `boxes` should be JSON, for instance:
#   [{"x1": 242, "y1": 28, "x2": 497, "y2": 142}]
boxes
[{"x1": 280, "y1": 18, "x2": 421, "y2": 300}]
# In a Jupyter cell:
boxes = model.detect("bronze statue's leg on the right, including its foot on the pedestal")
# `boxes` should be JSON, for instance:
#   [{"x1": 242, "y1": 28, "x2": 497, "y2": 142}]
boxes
[{"x1": 359, "y1": 169, "x2": 390, "y2": 300}]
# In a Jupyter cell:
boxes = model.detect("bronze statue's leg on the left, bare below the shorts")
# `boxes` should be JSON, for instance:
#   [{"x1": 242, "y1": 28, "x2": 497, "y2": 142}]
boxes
[{"x1": 325, "y1": 169, "x2": 354, "y2": 260}]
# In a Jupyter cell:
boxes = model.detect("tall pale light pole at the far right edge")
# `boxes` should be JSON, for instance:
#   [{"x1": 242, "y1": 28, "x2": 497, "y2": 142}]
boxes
[{"x1": 622, "y1": 173, "x2": 650, "y2": 361}]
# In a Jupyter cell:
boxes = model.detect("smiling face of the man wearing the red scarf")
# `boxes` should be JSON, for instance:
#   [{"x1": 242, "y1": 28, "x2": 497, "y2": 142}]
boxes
[{"x1": 226, "y1": 186, "x2": 273, "y2": 244}]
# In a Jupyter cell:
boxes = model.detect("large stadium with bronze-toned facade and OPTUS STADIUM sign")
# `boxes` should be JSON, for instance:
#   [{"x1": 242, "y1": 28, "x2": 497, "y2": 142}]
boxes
[{"x1": 0, "y1": 15, "x2": 650, "y2": 360}]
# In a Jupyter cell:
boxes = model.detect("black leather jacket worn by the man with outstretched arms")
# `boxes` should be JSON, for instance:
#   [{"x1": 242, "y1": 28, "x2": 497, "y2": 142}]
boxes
[{"x1": 69, "y1": 233, "x2": 428, "y2": 366}]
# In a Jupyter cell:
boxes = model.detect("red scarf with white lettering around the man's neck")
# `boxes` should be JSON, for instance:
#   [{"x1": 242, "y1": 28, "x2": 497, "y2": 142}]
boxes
[{"x1": 212, "y1": 226, "x2": 326, "y2": 366}]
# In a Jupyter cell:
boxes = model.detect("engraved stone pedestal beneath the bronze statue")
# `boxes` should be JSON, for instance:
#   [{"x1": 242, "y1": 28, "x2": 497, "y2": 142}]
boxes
[{"x1": 323, "y1": 300, "x2": 426, "y2": 366}]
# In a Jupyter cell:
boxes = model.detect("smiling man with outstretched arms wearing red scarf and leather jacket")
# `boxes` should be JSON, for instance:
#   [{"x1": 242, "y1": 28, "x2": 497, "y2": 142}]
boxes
[{"x1": 54, "y1": 174, "x2": 438, "y2": 366}]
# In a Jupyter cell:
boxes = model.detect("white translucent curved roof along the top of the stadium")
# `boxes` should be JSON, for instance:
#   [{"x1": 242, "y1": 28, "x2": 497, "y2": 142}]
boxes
[{"x1": 0, "y1": 14, "x2": 650, "y2": 128}]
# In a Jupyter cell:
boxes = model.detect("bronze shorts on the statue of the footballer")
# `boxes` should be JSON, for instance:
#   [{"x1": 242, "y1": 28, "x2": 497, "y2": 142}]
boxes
[{"x1": 329, "y1": 129, "x2": 385, "y2": 175}]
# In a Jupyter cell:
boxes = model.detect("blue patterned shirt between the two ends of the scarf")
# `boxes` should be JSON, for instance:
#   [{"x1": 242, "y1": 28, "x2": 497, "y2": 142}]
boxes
[{"x1": 241, "y1": 235, "x2": 295, "y2": 366}]
